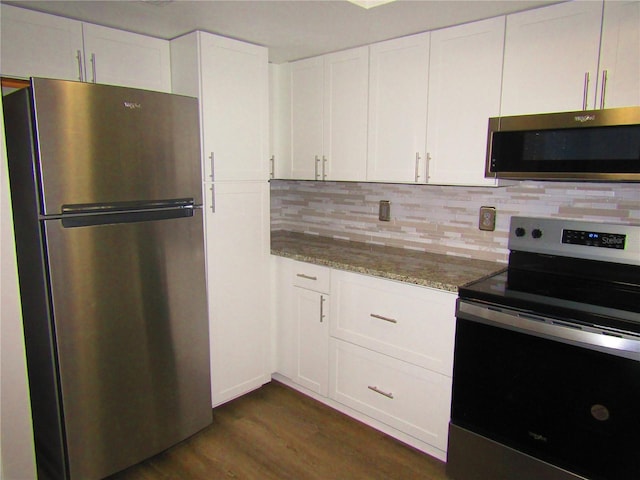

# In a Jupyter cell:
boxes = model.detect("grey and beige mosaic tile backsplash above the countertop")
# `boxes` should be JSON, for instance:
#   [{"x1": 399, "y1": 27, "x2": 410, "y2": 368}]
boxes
[{"x1": 271, "y1": 180, "x2": 640, "y2": 263}]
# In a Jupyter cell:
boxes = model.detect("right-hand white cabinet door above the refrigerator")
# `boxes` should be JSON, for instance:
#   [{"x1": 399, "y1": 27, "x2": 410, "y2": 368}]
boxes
[{"x1": 82, "y1": 23, "x2": 171, "y2": 92}]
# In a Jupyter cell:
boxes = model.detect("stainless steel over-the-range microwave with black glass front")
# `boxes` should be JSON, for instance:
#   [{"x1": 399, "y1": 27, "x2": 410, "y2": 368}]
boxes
[{"x1": 485, "y1": 106, "x2": 640, "y2": 182}]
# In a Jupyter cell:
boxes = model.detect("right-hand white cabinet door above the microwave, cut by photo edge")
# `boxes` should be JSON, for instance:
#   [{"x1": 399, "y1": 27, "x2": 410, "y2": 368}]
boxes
[{"x1": 596, "y1": 1, "x2": 640, "y2": 108}]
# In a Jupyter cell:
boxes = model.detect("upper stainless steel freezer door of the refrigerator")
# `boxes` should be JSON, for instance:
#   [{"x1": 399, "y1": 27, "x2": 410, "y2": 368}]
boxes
[{"x1": 33, "y1": 78, "x2": 202, "y2": 215}]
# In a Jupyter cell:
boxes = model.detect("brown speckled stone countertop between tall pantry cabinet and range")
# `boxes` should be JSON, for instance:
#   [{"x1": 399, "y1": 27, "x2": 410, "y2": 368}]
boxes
[{"x1": 271, "y1": 231, "x2": 506, "y2": 292}]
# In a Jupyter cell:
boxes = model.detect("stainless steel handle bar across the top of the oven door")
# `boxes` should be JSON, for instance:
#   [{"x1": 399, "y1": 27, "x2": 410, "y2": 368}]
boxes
[{"x1": 456, "y1": 299, "x2": 640, "y2": 362}]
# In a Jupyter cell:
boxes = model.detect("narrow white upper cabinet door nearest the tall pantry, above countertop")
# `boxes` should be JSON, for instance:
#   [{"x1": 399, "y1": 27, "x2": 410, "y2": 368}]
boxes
[{"x1": 291, "y1": 57, "x2": 324, "y2": 180}]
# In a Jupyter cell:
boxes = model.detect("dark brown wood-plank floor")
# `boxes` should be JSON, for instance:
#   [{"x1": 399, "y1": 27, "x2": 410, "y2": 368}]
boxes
[{"x1": 109, "y1": 381, "x2": 447, "y2": 480}]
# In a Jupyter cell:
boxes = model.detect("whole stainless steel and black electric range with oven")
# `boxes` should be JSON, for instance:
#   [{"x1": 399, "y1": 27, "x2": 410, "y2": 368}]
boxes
[{"x1": 447, "y1": 217, "x2": 640, "y2": 480}]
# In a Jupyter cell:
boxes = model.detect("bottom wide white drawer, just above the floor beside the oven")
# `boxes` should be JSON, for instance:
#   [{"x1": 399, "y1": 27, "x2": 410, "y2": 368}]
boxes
[{"x1": 329, "y1": 338, "x2": 451, "y2": 451}]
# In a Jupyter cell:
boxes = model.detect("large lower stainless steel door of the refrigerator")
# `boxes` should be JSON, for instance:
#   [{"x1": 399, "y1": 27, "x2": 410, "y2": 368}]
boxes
[{"x1": 45, "y1": 209, "x2": 212, "y2": 480}]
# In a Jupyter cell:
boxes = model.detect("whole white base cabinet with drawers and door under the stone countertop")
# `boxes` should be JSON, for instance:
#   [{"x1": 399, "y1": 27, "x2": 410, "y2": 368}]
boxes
[{"x1": 274, "y1": 257, "x2": 456, "y2": 459}]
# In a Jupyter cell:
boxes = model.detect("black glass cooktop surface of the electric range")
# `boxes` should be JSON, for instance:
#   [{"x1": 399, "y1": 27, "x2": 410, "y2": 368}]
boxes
[{"x1": 459, "y1": 253, "x2": 640, "y2": 335}]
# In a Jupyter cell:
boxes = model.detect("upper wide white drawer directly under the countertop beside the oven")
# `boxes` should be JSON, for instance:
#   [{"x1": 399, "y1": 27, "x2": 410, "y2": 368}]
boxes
[{"x1": 330, "y1": 272, "x2": 457, "y2": 376}]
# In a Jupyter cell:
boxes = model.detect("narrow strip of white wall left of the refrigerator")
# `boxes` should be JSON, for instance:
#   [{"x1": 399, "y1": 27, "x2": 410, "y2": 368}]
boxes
[{"x1": 0, "y1": 97, "x2": 36, "y2": 480}]
